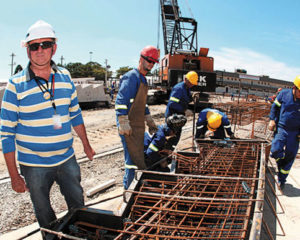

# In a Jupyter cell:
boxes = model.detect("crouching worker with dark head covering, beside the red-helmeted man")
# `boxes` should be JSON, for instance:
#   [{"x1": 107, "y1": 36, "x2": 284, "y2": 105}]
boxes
[{"x1": 144, "y1": 114, "x2": 187, "y2": 172}]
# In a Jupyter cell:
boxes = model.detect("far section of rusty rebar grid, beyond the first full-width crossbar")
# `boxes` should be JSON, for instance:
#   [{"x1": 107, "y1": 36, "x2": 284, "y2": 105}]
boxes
[{"x1": 176, "y1": 141, "x2": 261, "y2": 177}]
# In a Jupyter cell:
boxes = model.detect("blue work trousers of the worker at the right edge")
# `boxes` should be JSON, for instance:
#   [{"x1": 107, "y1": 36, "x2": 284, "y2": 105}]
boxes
[{"x1": 271, "y1": 127, "x2": 299, "y2": 183}]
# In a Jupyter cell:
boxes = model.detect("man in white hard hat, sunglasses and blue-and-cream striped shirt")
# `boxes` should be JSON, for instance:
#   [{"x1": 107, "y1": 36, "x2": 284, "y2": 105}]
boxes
[{"x1": 1, "y1": 21, "x2": 95, "y2": 226}]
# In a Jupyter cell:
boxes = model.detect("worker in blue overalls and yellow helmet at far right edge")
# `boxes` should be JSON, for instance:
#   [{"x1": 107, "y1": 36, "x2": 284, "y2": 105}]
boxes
[{"x1": 268, "y1": 75, "x2": 300, "y2": 189}]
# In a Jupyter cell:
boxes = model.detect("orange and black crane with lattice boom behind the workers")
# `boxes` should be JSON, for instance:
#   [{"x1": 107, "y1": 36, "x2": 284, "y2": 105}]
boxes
[{"x1": 147, "y1": 0, "x2": 216, "y2": 104}]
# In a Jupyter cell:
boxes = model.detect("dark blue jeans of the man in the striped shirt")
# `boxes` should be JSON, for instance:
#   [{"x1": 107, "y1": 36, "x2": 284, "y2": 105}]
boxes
[{"x1": 20, "y1": 156, "x2": 84, "y2": 227}]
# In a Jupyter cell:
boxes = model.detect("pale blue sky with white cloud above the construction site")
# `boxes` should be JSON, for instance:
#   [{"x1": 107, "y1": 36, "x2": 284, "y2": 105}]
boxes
[{"x1": 0, "y1": 0, "x2": 300, "y2": 81}]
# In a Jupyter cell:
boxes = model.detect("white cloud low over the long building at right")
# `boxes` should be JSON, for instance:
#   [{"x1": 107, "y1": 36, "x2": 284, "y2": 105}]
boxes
[{"x1": 210, "y1": 47, "x2": 300, "y2": 81}]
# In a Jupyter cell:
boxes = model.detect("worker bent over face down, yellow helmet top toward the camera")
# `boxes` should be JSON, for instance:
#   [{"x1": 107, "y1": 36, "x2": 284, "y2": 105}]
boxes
[{"x1": 195, "y1": 108, "x2": 235, "y2": 139}]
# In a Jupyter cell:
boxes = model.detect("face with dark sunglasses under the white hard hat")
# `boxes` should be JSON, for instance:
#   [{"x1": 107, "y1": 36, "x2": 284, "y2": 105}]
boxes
[{"x1": 27, "y1": 38, "x2": 56, "y2": 66}]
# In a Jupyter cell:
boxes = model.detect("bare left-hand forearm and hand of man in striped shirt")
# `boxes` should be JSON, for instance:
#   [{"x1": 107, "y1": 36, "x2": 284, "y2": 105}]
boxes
[{"x1": 4, "y1": 152, "x2": 28, "y2": 193}]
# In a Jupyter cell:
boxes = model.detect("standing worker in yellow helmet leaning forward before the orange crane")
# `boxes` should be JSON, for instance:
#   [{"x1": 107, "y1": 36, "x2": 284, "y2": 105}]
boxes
[{"x1": 165, "y1": 71, "x2": 198, "y2": 146}]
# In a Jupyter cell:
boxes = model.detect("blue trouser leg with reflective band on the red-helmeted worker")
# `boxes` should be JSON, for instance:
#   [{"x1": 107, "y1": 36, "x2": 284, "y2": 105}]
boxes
[{"x1": 119, "y1": 135, "x2": 137, "y2": 189}]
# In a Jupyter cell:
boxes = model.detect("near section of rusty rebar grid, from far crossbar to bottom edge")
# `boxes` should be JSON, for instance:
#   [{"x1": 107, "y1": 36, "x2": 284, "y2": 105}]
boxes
[{"x1": 116, "y1": 176, "x2": 257, "y2": 239}]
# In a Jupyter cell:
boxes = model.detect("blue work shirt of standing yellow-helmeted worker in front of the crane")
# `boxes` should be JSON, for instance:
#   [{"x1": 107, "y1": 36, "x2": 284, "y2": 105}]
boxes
[{"x1": 165, "y1": 82, "x2": 192, "y2": 118}]
